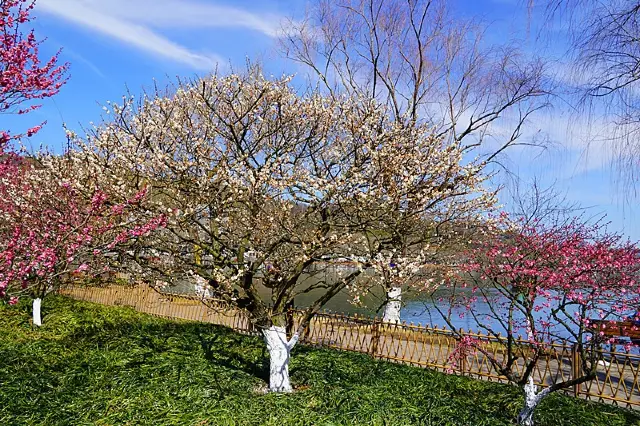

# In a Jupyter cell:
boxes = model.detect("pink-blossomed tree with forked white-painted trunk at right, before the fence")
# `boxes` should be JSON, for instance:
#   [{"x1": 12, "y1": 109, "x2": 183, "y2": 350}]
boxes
[{"x1": 436, "y1": 215, "x2": 640, "y2": 425}]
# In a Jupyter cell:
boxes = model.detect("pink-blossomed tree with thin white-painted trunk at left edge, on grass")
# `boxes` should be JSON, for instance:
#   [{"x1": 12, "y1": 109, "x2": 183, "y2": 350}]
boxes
[{"x1": 0, "y1": 154, "x2": 164, "y2": 325}]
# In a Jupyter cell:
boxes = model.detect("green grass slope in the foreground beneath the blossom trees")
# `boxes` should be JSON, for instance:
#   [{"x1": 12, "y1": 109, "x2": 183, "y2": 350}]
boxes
[{"x1": 0, "y1": 297, "x2": 640, "y2": 426}]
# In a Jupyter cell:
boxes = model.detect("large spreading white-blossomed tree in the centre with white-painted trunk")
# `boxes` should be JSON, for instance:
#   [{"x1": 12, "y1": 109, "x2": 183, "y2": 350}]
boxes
[{"x1": 70, "y1": 68, "x2": 494, "y2": 392}]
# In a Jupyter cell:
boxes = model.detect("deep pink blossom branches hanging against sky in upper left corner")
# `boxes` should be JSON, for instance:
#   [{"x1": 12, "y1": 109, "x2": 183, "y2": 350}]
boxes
[{"x1": 0, "y1": 0, "x2": 69, "y2": 146}]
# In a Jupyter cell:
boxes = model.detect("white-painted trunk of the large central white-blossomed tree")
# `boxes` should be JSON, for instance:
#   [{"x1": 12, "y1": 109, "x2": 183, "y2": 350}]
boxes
[{"x1": 262, "y1": 325, "x2": 298, "y2": 392}]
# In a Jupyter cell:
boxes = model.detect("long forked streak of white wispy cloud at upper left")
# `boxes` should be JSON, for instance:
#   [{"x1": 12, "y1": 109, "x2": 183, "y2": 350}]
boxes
[{"x1": 37, "y1": 0, "x2": 280, "y2": 70}]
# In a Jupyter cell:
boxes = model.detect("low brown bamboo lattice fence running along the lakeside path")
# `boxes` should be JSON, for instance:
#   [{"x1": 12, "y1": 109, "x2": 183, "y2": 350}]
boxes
[{"x1": 61, "y1": 285, "x2": 640, "y2": 409}]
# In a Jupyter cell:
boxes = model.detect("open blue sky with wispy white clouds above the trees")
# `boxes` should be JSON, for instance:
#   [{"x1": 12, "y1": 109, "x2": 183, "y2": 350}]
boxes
[{"x1": 0, "y1": 0, "x2": 640, "y2": 240}]
